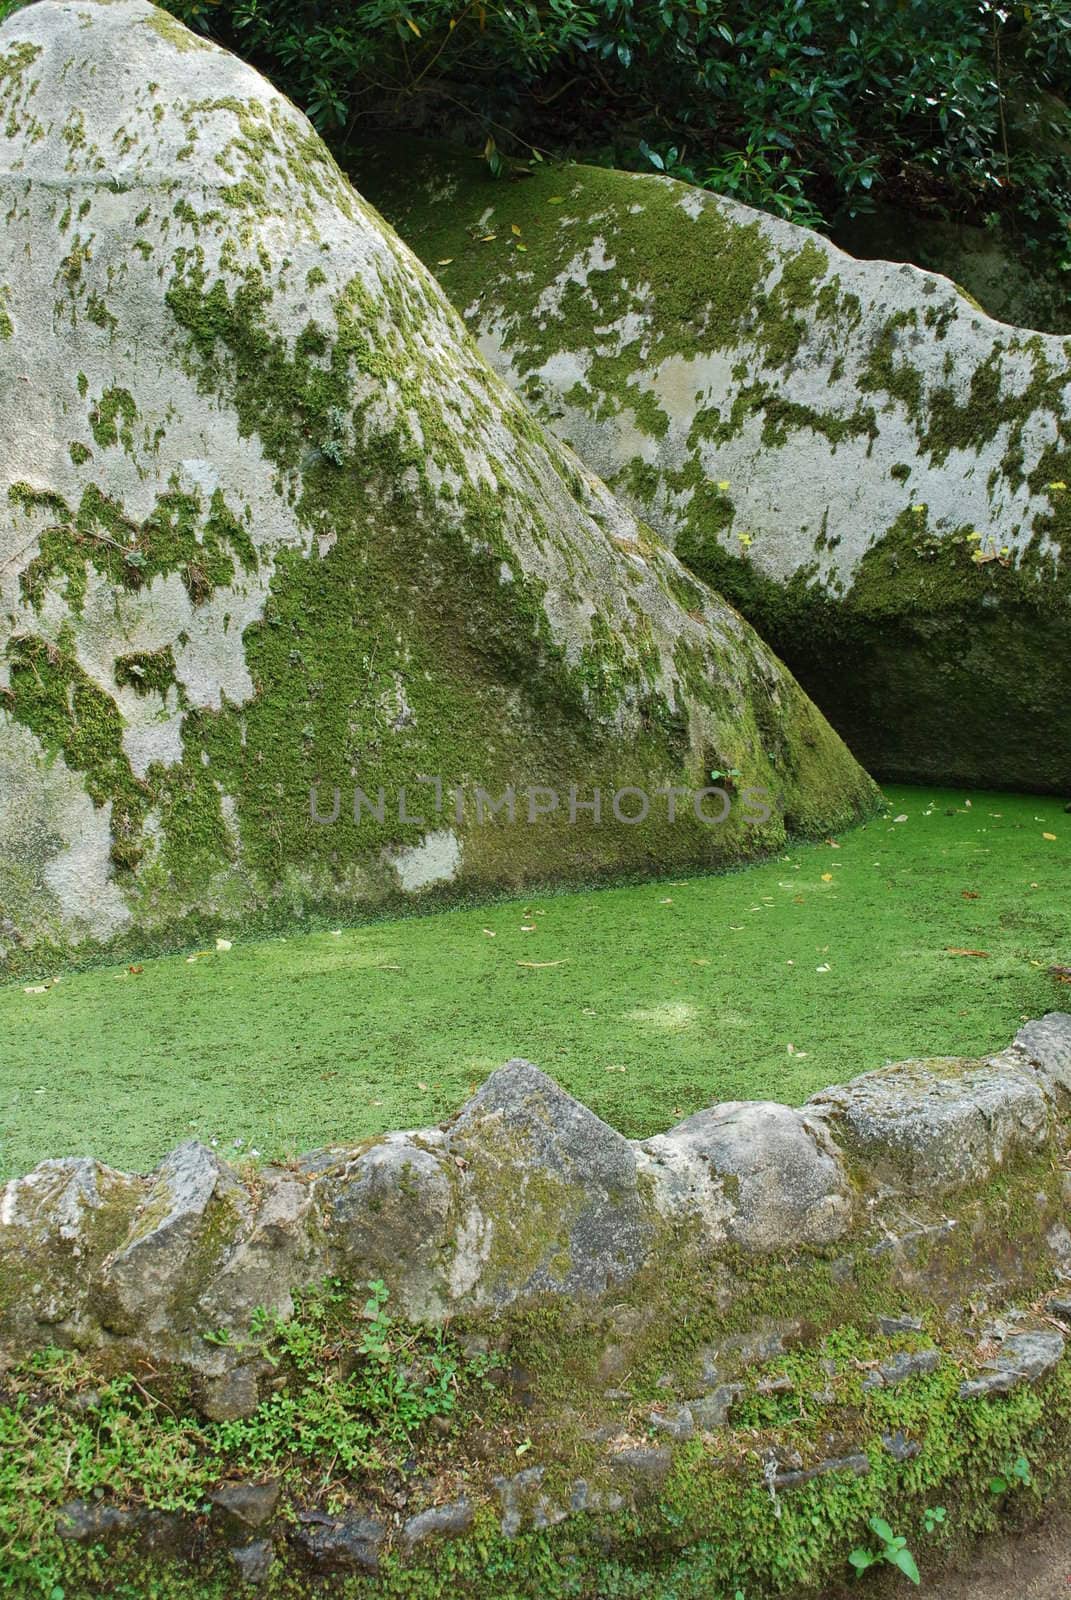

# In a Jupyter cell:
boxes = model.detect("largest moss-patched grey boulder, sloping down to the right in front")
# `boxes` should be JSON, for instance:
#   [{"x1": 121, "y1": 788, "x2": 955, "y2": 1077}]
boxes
[{"x1": 0, "y1": 0, "x2": 874, "y2": 963}]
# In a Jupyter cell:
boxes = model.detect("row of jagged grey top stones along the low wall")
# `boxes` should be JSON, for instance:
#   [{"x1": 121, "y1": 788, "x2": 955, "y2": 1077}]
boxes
[{"x1": 0, "y1": 1013, "x2": 1071, "y2": 1379}]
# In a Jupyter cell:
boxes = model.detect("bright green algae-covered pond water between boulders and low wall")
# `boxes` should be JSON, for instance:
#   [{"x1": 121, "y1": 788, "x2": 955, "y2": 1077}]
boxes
[{"x1": 0, "y1": 787, "x2": 1071, "y2": 1176}]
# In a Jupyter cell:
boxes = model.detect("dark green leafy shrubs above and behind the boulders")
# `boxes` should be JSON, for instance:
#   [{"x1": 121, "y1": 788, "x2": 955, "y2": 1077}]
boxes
[{"x1": 154, "y1": 0, "x2": 1071, "y2": 259}]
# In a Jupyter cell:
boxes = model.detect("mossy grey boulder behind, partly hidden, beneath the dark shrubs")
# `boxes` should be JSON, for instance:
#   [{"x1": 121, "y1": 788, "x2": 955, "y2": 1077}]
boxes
[{"x1": 351, "y1": 142, "x2": 1071, "y2": 790}]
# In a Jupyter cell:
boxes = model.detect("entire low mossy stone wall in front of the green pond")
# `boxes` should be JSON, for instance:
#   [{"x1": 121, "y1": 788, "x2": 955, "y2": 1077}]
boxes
[{"x1": 0, "y1": 1014, "x2": 1071, "y2": 1600}]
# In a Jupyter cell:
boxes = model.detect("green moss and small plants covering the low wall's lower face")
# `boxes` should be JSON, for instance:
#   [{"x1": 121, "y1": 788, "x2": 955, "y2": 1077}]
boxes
[{"x1": 0, "y1": 1168, "x2": 1071, "y2": 1600}]
